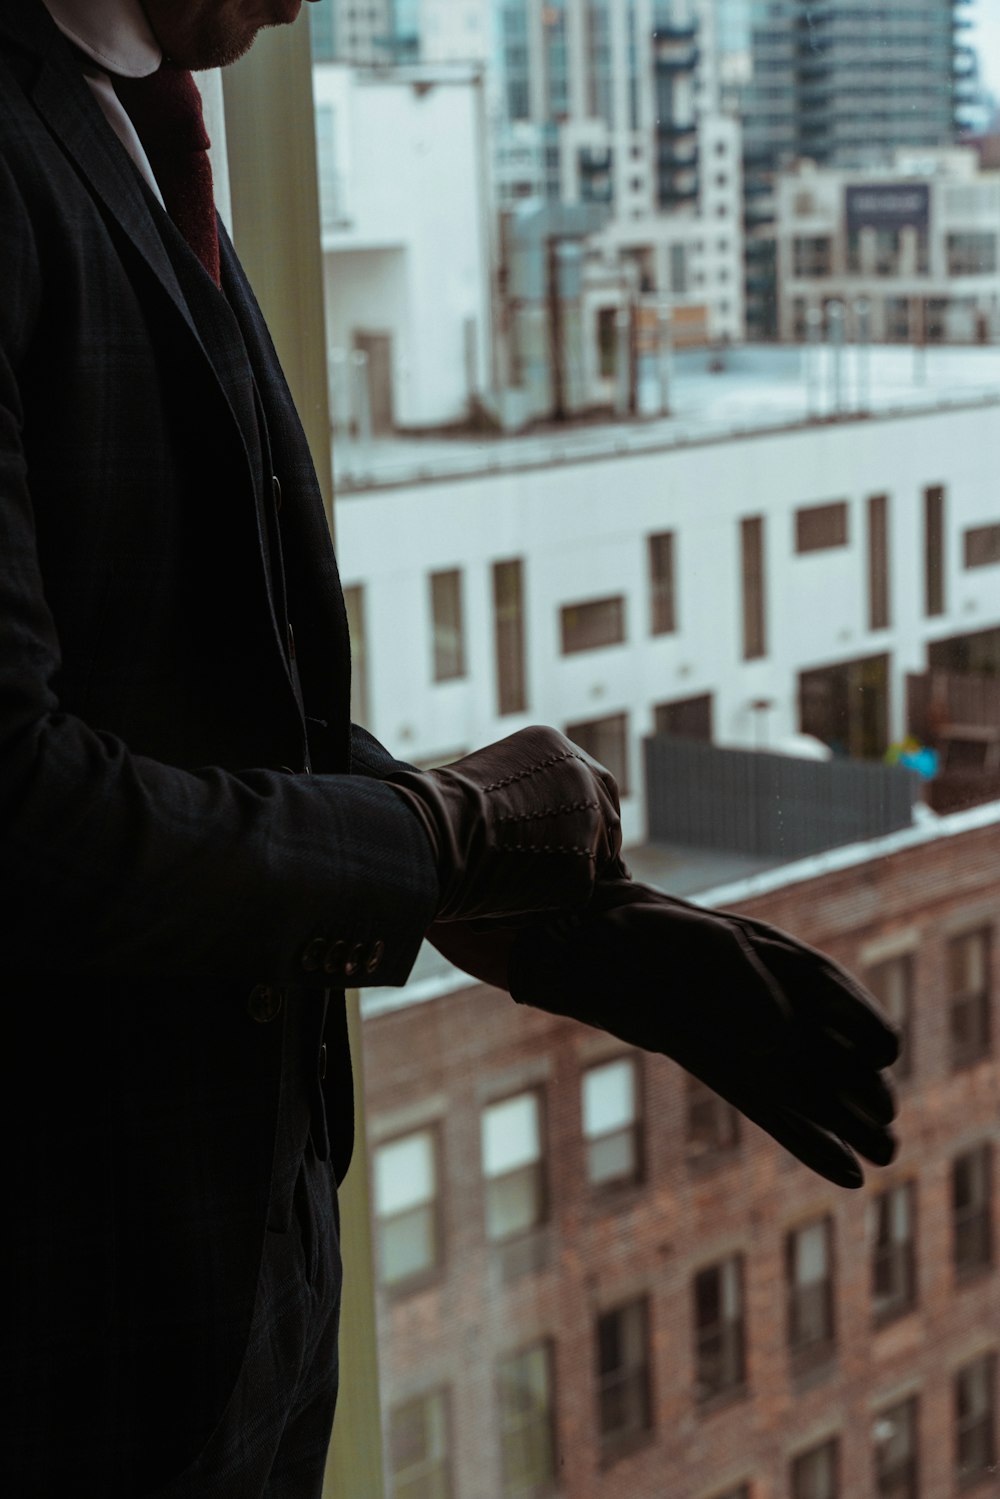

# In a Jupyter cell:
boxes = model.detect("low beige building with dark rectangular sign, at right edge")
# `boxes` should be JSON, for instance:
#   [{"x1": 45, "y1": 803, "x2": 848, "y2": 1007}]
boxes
[{"x1": 775, "y1": 147, "x2": 1000, "y2": 343}]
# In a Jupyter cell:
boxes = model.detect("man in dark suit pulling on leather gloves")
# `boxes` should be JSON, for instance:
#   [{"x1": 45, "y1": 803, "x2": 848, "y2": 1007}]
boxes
[{"x1": 0, "y1": 0, "x2": 905, "y2": 1499}]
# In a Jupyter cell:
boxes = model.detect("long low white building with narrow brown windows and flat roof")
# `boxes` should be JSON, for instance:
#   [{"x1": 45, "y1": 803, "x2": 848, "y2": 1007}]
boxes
[{"x1": 334, "y1": 349, "x2": 1000, "y2": 841}]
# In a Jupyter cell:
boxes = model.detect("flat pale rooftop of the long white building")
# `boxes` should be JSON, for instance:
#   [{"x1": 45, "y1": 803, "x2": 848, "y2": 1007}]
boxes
[{"x1": 333, "y1": 345, "x2": 1000, "y2": 496}]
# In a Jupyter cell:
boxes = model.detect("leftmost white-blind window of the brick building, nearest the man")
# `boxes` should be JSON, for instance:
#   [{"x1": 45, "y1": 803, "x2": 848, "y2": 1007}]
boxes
[{"x1": 375, "y1": 1129, "x2": 441, "y2": 1286}]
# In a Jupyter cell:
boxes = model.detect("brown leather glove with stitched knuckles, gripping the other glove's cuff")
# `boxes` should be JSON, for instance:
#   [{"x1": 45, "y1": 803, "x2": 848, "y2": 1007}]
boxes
[{"x1": 388, "y1": 727, "x2": 622, "y2": 922}]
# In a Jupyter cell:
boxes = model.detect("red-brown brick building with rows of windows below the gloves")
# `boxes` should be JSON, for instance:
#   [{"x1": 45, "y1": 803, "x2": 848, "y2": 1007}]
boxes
[{"x1": 364, "y1": 803, "x2": 1000, "y2": 1499}]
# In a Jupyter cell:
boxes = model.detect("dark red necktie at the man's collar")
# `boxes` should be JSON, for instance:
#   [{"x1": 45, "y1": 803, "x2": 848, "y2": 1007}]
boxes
[{"x1": 114, "y1": 63, "x2": 219, "y2": 286}]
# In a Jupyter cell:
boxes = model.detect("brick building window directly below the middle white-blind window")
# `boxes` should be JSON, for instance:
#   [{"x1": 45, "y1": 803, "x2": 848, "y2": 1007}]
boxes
[{"x1": 498, "y1": 1343, "x2": 556, "y2": 1499}]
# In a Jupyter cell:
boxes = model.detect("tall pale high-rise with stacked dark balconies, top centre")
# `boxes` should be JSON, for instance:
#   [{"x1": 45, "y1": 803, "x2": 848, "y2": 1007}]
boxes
[{"x1": 489, "y1": 0, "x2": 744, "y2": 343}]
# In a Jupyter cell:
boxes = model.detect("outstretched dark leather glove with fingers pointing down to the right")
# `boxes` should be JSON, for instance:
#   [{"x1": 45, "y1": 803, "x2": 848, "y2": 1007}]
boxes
[{"x1": 510, "y1": 878, "x2": 898, "y2": 1187}]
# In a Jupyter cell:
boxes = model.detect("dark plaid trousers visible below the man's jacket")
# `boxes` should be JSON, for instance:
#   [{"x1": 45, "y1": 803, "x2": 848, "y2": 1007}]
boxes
[{"x1": 154, "y1": 1142, "x2": 340, "y2": 1499}]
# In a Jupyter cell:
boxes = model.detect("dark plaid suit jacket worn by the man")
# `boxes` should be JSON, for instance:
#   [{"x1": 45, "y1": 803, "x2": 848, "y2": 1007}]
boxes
[{"x1": 0, "y1": 0, "x2": 436, "y2": 1499}]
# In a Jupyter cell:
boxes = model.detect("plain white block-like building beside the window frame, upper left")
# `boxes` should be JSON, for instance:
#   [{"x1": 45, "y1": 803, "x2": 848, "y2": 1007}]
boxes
[{"x1": 315, "y1": 64, "x2": 492, "y2": 432}]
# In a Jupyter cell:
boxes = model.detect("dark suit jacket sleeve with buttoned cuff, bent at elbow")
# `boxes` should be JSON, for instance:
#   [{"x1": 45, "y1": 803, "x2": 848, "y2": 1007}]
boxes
[{"x1": 0, "y1": 160, "x2": 438, "y2": 997}]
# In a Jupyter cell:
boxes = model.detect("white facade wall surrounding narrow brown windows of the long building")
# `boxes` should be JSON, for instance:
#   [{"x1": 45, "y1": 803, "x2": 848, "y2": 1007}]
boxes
[{"x1": 337, "y1": 408, "x2": 1000, "y2": 841}]
